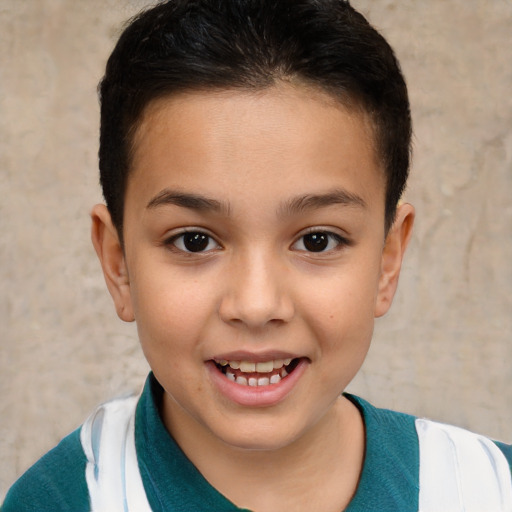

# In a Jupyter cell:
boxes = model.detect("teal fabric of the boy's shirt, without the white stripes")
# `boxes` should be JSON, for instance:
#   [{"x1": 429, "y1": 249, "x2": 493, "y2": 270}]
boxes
[{"x1": 2, "y1": 374, "x2": 512, "y2": 512}]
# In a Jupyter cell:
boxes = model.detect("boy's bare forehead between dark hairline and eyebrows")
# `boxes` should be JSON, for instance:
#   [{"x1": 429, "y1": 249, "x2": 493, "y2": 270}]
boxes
[{"x1": 128, "y1": 83, "x2": 385, "y2": 211}]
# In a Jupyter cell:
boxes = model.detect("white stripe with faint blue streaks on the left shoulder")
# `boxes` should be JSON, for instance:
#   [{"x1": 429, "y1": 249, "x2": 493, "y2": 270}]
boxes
[{"x1": 80, "y1": 396, "x2": 151, "y2": 512}]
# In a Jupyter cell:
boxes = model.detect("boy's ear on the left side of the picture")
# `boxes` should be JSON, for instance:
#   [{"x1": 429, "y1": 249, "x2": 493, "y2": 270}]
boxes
[{"x1": 91, "y1": 204, "x2": 135, "y2": 322}]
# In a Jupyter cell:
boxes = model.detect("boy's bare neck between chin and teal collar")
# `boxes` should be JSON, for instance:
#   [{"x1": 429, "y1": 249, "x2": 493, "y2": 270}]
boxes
[{"x1": 164, "y1": 397, "x2": 364, "y2": 512}]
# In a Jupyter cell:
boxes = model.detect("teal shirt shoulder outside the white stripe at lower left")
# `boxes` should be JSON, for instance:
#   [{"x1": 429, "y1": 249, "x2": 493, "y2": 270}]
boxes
[{"x1": 2, "y1": 429, "x2": 89, "y2": 512}]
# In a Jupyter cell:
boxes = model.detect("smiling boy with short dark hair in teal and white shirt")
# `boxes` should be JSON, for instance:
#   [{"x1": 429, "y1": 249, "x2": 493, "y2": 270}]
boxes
[{"x1": 3, "y1": 0, "x2": 512, "y2": 512}]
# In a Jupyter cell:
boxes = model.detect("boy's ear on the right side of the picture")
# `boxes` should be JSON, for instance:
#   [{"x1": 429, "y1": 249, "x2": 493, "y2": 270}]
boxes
[{"x1": 375, "y1": 203, "x2": 414, "y2": 317}]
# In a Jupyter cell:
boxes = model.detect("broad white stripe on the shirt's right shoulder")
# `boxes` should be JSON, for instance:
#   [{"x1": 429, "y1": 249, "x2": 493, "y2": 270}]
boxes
[{"x1": 416, "y1": 419, "x2": 512, "y2": 512}]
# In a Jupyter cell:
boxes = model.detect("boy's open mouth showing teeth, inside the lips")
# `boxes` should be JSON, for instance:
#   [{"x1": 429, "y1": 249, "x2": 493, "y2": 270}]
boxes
[{"x1": 214, "y1": 358, "x2": 300, "y2": 387}]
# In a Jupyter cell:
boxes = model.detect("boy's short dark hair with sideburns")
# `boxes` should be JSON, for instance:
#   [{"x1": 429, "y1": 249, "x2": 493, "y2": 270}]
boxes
[{"x1": 99, "y1": 0, "x2": 411, "y2": 238}]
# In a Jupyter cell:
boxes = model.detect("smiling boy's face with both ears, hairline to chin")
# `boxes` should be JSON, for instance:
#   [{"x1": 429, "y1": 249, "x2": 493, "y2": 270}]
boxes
[{"x1": 93, "y1": 85, "x2": 412, "y2": 450}]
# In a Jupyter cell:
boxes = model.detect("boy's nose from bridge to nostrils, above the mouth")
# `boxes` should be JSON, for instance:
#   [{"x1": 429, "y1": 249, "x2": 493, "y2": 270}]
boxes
[{"x1": 219, "y1": 252, "x2": 295, "y2": 329}]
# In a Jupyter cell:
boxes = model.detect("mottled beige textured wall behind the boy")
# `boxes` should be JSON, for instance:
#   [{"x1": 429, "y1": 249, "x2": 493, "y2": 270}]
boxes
[{"x1": 0, "y1": 0, "x2": 512, "y2": 499}]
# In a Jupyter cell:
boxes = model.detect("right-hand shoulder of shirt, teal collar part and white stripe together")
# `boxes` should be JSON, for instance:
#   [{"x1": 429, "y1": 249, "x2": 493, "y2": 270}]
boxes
[{"x1": 345, "y1": 395, "x2": 512, "y2": 512}]
